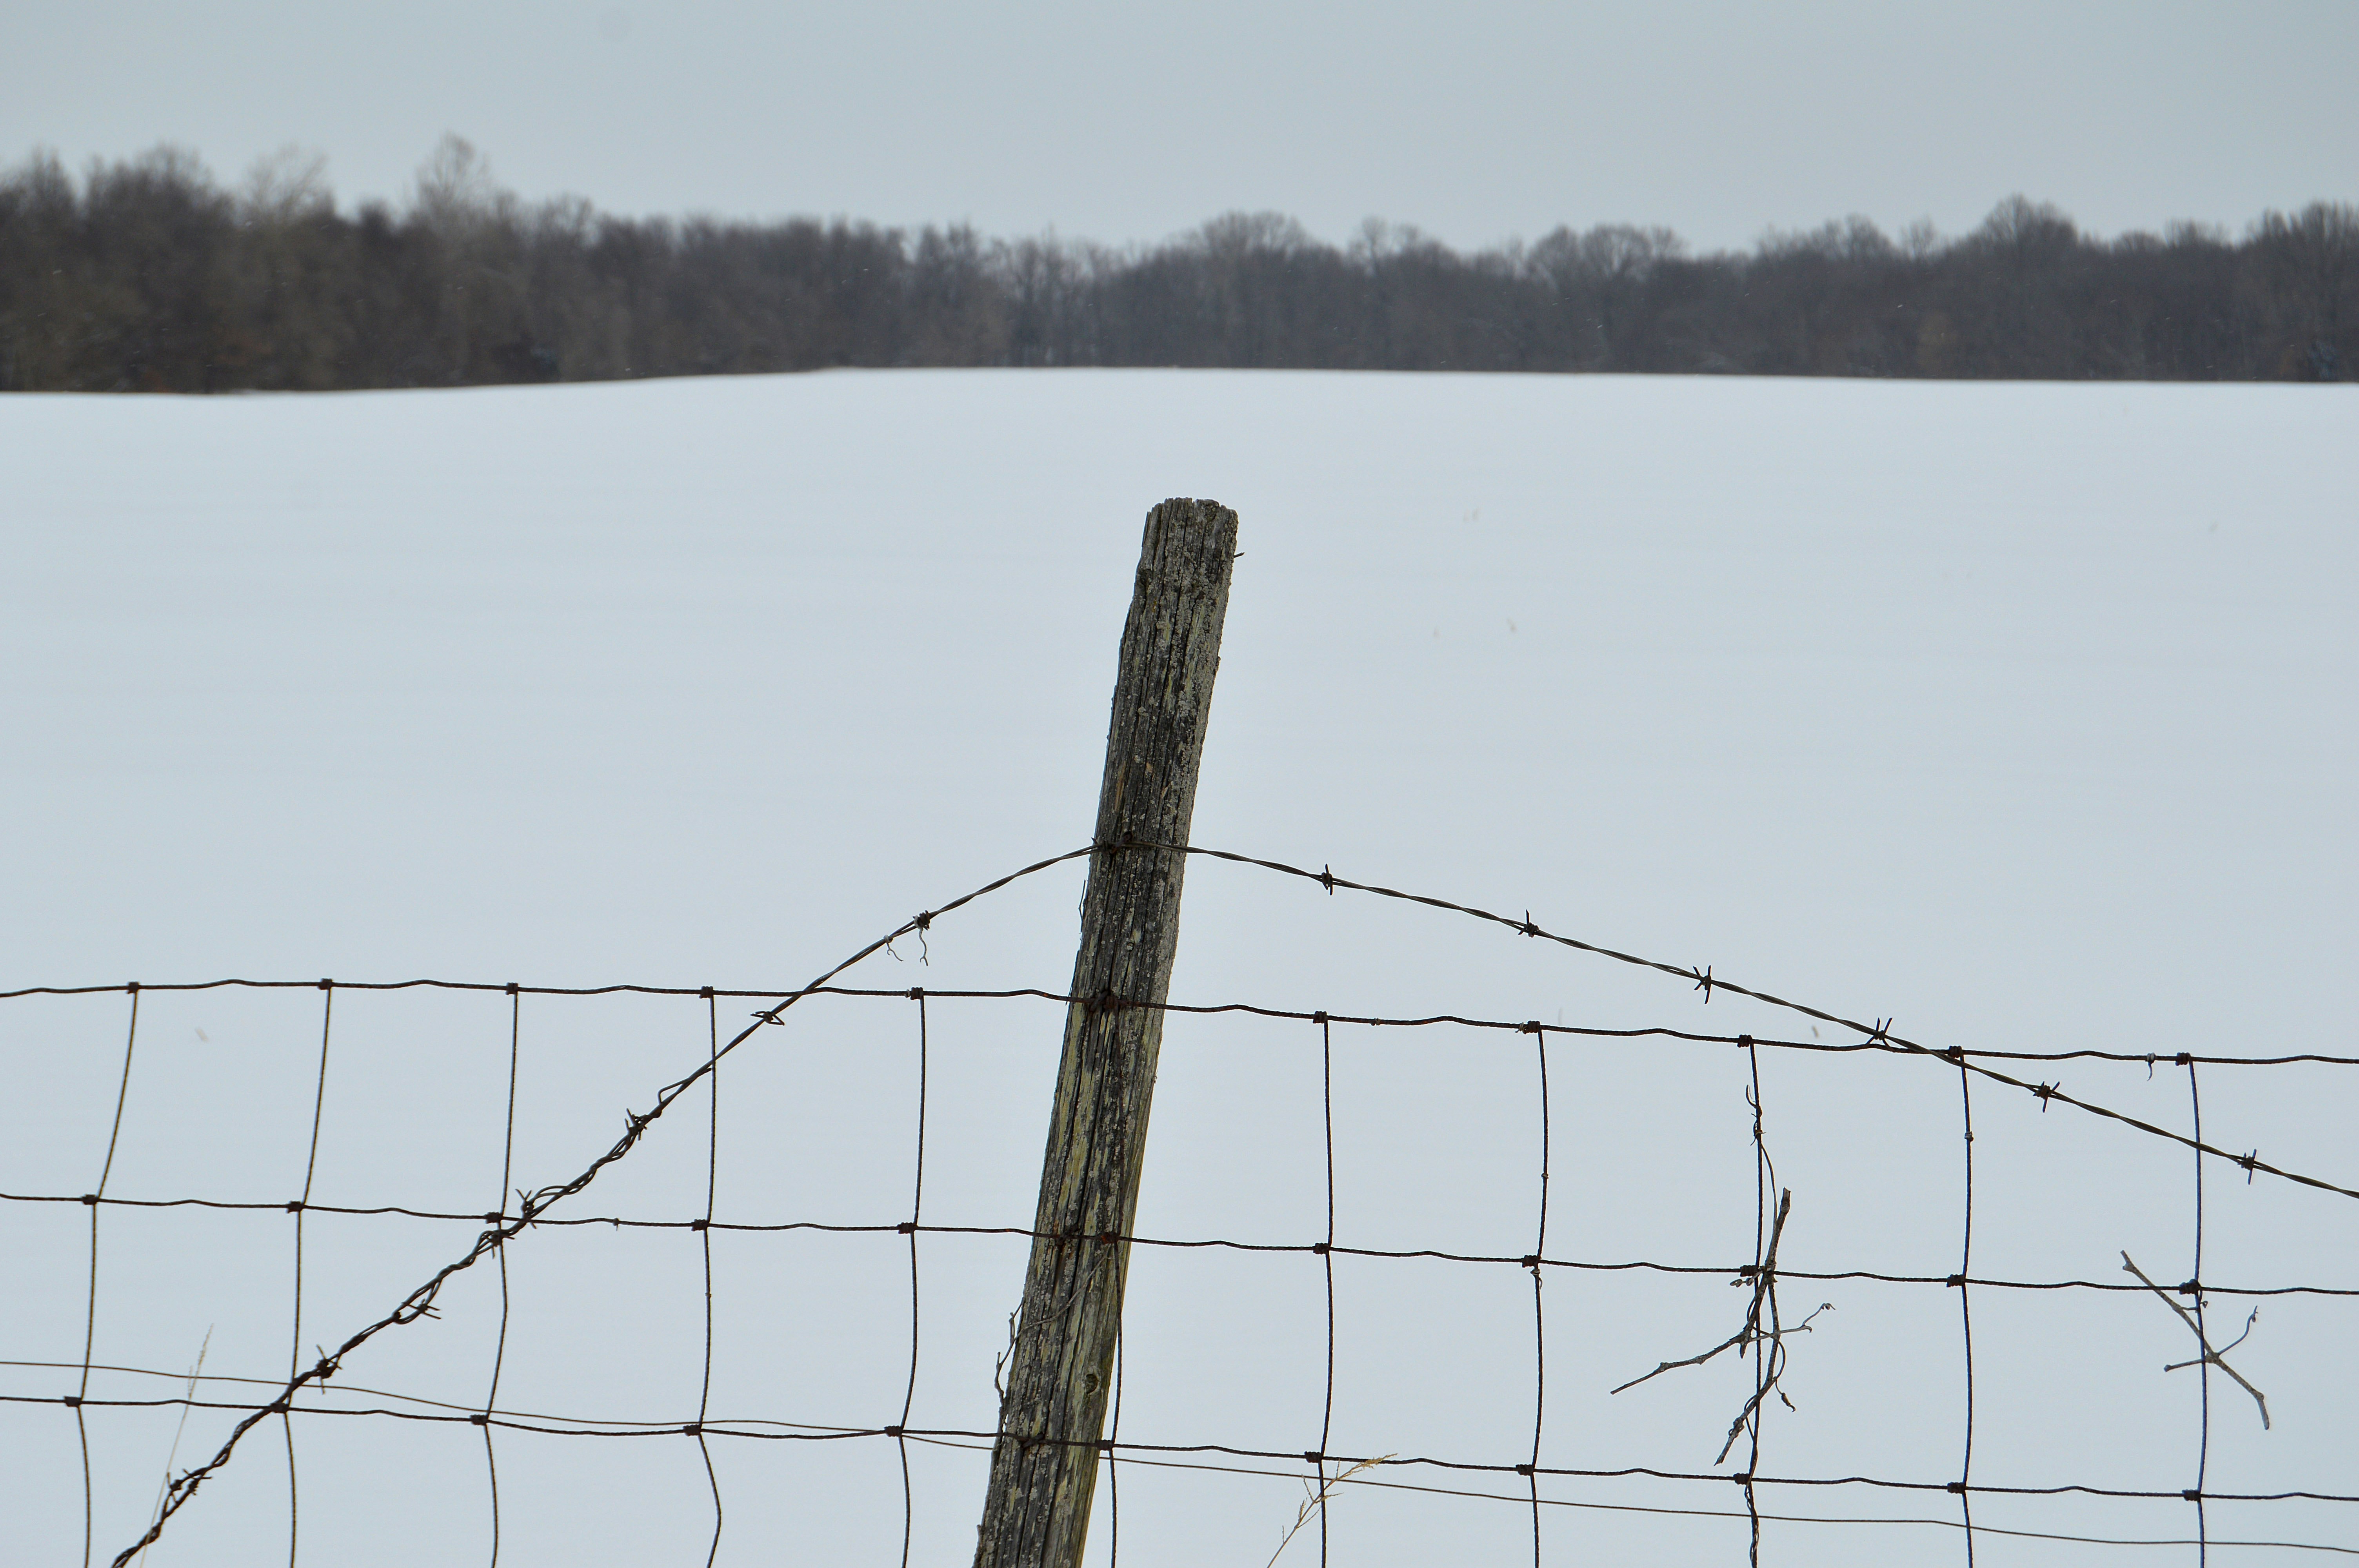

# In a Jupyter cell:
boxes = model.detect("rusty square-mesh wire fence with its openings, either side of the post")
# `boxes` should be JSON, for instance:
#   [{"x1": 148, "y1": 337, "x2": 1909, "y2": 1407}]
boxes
[{"x1": 0, "y1": 846, "x2": 2359, "y2": 1563}]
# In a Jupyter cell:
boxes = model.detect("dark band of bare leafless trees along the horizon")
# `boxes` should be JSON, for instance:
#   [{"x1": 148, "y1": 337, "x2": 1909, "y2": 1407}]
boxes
[{"x1": 0, "y1": 137, "x2": 2359, "y2": 391}]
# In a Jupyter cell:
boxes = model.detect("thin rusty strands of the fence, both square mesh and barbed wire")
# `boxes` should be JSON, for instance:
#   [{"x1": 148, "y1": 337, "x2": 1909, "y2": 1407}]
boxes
[{"x1": 0, "y1": 842, "x2": 2359, "y2": 1568}]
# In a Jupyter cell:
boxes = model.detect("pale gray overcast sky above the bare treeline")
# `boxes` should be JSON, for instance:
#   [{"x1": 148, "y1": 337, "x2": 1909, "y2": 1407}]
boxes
[{"x1": 0, "y1": 0, "x2": 2359, "y2": 248}]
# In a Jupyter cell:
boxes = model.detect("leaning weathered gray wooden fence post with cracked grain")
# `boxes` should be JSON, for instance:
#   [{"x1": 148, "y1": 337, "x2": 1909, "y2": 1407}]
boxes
[{"x1": 974, "y1": 500, "x2": 1236, "y2": 1568}]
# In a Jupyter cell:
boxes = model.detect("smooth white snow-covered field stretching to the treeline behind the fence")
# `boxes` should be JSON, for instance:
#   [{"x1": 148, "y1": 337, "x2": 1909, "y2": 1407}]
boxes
[{"x1": 0, "y1": 372, "x2": 2359, "y2": 1566}]
